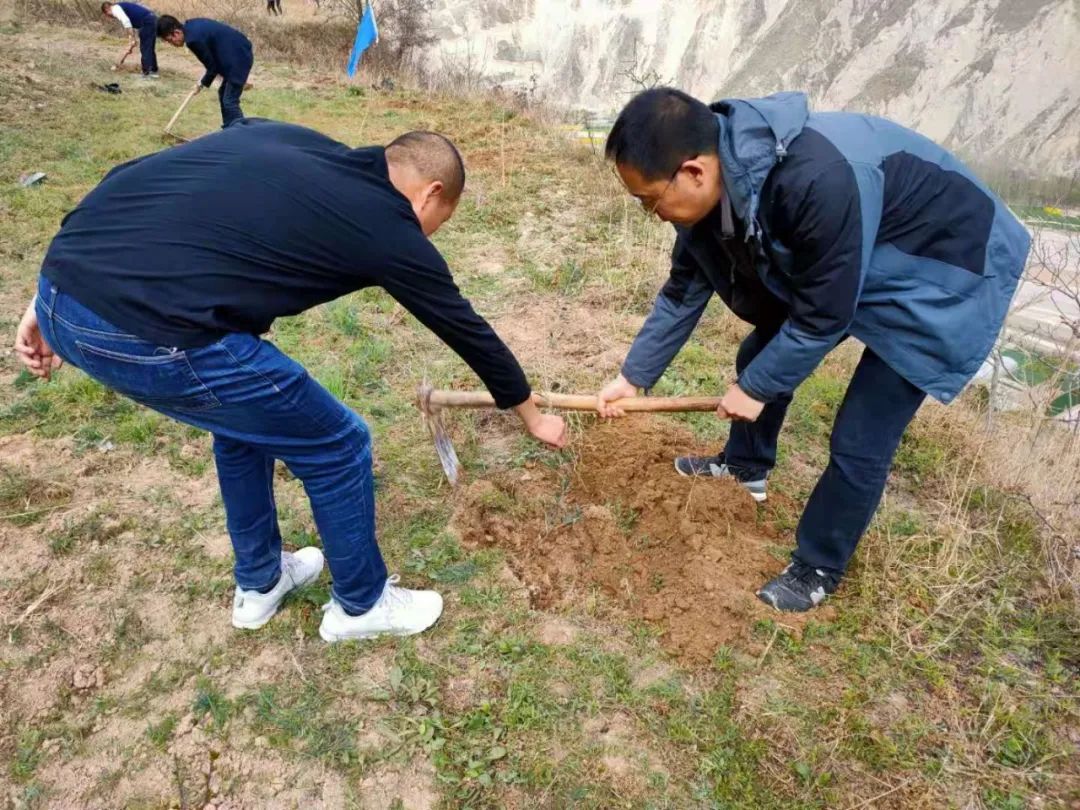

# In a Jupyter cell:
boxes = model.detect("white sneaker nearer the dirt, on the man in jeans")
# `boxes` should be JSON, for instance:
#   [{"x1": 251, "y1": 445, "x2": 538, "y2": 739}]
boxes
[{"x1": 319, "y1": 573, "x2": 443, "y2": 642}]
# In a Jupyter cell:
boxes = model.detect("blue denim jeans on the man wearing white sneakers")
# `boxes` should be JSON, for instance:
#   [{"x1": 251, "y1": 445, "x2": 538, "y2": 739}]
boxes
[{"x1": 36, "y1": 276, "x2": 387, "y2": 615}]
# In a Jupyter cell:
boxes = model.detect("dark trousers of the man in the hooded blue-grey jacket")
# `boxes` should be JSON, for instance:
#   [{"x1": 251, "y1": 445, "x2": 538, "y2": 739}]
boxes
[{"x1": 724, "y1": 329, "x2": 926, "y2": 572}]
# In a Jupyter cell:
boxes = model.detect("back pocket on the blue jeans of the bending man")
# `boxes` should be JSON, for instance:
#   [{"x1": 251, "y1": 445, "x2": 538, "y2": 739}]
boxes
[{"x1": 76, "y1": 340, "x2": 220, "y2": 411}]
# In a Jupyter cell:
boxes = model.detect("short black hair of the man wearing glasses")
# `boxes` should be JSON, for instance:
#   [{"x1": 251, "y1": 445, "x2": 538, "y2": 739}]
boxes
[{"x1": 604, "y1": 87, "x2": 719, "y2": 180}]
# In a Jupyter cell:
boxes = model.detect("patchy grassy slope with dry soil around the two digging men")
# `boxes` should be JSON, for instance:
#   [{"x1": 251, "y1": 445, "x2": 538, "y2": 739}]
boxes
[{"x1": 0, "y1": 19, "x2": 1080, "y2": 808}]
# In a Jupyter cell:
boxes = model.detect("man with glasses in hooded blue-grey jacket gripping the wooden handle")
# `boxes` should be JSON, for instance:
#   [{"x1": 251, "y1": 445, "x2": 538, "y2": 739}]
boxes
[{"x1": 597, "y1": 87, "x2": 1030, "y2": 611}]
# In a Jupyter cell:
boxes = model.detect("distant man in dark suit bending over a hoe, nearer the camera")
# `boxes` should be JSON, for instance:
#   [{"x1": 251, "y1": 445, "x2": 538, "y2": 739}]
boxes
[{"x1": 158, "y1": 14, "x2": 255, "y2": 126}]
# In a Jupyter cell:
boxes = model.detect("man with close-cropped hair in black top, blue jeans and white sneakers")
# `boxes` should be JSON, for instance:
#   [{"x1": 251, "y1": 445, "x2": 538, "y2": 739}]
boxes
[{"x1": 15, "y1": 119, "x2": 566, "y2": 642}]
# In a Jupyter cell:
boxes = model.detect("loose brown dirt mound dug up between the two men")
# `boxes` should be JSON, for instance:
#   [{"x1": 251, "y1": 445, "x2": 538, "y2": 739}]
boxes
[{"x1": 455, "y1": 417, "x2": 812, "y2": 662}]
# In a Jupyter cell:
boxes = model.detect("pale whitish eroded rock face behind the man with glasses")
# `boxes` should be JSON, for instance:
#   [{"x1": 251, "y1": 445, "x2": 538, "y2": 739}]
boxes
[{"x1": 426, "y1": 0, "x2": 1080, "y2": 175}]
